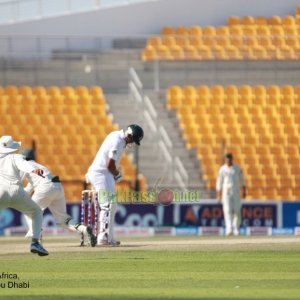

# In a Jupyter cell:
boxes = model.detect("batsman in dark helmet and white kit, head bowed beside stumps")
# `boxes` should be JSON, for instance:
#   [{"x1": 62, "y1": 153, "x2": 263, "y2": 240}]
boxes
[{"x1": 86, "y1": 124, "x2": 144, "y2": 246}]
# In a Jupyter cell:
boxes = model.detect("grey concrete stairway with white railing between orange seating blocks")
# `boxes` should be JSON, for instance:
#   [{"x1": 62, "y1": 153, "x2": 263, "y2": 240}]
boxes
[{"x1": 106, "y1": 91, "x2": 208, "y2": 196}]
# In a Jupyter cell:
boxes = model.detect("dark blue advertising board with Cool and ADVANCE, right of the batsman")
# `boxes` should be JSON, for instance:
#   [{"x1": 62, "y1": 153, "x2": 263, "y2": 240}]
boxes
[{"x1": 116, "y1": 201, "x2": 278, "y2": 227}]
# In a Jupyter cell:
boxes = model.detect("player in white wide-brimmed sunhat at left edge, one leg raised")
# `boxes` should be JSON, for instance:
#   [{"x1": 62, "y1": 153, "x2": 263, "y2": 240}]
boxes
[{"x1": 0, "y1": 136, "x2": 49, "y2": 256}]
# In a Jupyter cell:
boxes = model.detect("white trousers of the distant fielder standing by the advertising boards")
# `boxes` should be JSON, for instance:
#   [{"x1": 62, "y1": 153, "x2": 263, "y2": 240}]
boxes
[{"x1": 222, "y1": 193, "x2": 241, "y2": 234}]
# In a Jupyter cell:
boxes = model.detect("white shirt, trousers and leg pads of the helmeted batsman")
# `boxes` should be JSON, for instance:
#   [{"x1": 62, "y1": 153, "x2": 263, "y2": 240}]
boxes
[{"x1": 87, "y1": 130, "x2": 125, "y2": 241}]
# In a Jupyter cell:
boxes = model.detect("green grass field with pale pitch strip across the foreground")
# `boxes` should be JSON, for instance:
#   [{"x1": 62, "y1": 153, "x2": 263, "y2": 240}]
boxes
[{"x1": 0, "y1": 237, "x2": 300, "y2": 300}]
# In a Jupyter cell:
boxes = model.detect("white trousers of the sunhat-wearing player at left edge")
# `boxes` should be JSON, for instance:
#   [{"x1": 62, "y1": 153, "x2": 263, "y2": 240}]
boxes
[{"x1": 0, "y1": 185, "x2": 43, "y2": 239}]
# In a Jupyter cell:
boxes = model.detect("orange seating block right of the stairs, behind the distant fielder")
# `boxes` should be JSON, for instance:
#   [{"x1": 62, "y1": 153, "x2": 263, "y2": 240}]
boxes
[{"x1": 167, "y1": 85, "x2": 300, "y2": 200}]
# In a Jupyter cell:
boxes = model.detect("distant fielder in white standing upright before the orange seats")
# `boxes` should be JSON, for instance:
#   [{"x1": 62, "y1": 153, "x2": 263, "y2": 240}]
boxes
[{"x1": 216, "y1": 153, "x2": 246, "y2": 236}]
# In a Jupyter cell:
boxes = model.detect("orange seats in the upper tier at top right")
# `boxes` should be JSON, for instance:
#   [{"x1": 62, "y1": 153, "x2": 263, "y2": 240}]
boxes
[{"x1": 142, "y1": 9, "x2": 300, "y2": 61}]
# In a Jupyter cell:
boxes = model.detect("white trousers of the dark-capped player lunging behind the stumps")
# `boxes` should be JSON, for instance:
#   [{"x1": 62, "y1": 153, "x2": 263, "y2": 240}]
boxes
[{"x1": 26, "y1": 182, "x2": 76, "y2": 237}]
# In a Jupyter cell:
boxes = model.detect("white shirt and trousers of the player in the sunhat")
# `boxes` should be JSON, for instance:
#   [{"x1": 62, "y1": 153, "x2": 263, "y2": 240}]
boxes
[{"x1": 0, "y1": 154, "x2": 43, "y2": 239}]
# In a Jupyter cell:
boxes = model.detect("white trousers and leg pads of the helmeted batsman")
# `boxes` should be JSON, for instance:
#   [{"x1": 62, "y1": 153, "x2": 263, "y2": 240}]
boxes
[{"x1": 88, "y1": 170, "x2": 117, "y2": 241}]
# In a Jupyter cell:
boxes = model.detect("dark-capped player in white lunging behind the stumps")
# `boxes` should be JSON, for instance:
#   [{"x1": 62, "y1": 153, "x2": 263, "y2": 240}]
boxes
[{"x1": 21, "y1": 149, "x2": 97, "y2": 247}]
